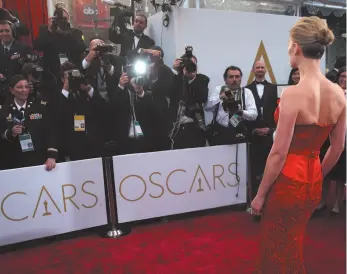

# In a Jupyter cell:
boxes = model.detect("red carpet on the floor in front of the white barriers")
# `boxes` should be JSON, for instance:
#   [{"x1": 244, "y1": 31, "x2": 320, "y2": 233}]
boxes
[{"x1": 0, "y1": 208, "x2": 346, "y2": 274}]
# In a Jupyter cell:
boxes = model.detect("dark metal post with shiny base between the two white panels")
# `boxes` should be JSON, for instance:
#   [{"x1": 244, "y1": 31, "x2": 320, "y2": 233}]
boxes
[{"x1": 103, "y1": 157, "x2": 123, "y2": 238}]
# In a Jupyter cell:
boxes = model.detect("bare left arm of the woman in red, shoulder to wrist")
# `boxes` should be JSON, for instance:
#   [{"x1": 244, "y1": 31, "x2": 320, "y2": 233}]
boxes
[{"x1": 257, "y1": 87, "x2": 298, "y2": 198}]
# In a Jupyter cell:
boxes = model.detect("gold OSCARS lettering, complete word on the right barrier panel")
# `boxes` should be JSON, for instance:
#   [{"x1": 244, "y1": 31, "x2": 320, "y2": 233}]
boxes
[{"x1": 118, "y1": 163, "x2": 240, "y2": 202}]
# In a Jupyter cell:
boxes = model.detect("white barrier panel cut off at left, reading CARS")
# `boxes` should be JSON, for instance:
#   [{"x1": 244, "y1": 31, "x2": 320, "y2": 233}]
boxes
[{"x1": 0, "y1": 159, "x2": 107, "y2": 246}]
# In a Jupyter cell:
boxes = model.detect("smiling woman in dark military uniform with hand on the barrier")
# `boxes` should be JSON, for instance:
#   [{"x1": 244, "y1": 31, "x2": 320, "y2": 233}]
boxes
[{"x1": 0, "y1": 75, "x2": 58, "y2": 170}]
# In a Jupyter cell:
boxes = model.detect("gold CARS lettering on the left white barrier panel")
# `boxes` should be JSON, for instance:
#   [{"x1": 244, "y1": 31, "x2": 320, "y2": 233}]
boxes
[{"x1": 0, "y1": 181, "x2": 99, "y2": 222}]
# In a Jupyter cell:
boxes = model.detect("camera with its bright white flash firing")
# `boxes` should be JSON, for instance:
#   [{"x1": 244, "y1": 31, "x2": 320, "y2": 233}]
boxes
[{"x1": 123, "y1": 58, "x2": 150, "y2": 86}]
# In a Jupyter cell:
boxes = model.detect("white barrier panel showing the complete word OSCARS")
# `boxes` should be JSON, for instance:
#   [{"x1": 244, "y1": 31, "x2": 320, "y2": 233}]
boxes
[{"x1": 113, "y1": 144, "x2": 247, "y2": 223}]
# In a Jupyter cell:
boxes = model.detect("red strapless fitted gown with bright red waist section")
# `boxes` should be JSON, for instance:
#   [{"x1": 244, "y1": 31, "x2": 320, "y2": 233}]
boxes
[{"x1": 258, "y1": 103, "x2": 333, "y2": 274}]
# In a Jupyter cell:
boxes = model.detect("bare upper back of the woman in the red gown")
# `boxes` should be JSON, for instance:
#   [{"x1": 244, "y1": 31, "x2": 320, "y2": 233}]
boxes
[{"x1": 295, "y1": 75, "x2": 346, "y2": 126}]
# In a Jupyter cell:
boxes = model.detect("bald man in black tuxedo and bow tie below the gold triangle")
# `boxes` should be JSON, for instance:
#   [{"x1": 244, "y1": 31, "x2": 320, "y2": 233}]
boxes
[{"x1": 246, "y1": 60, "x2": 277, "y2": 219}]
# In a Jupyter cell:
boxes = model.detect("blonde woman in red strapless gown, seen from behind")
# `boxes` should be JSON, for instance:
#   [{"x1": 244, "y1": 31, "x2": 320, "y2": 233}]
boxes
[{"x1": 251, "y1": 16, "x2": 346, "y2": 274}]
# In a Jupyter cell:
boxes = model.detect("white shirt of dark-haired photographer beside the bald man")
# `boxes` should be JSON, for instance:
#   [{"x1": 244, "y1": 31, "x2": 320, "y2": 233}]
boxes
[{"x1": 206, "y1": 86, "x2": 258, "y2": 127}]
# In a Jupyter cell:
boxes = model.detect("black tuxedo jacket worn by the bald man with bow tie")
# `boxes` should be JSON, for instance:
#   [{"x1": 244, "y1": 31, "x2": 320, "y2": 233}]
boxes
[{"x1": 246, "y1": 82, "x2": 277, "y2": 129}]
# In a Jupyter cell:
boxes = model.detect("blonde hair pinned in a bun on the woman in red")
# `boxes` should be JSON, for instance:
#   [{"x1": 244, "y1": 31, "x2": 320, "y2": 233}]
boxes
[{"x1": 290, "y1": 16, "x2": 335, "y2": 59}]
